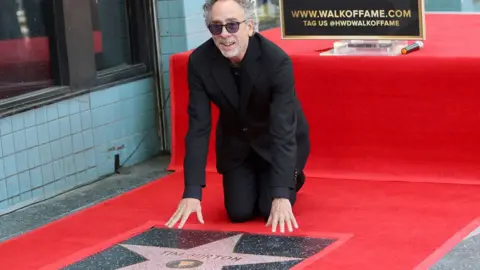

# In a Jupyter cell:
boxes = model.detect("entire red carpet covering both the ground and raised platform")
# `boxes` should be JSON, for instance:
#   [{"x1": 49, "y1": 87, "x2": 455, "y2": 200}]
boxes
[{"x1": 0, "y1": 15, "x2": 480, "y2": 270}]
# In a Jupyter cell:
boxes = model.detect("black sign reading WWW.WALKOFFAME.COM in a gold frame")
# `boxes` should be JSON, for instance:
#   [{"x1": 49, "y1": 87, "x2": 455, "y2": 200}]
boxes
[{"x1": 280, "y1": 0, "x2": 424, "y2": 40}]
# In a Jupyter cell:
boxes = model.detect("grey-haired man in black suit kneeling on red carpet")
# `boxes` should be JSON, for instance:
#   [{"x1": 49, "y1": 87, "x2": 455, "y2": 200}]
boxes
[{"x1": 166, "y1": 0, "x2": 310, "y2": 232}]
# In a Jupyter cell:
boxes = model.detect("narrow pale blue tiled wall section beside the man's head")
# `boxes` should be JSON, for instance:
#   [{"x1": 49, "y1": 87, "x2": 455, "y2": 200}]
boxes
[{"x1": 157, "y1": 0, "x2": 210, "y2": 148}]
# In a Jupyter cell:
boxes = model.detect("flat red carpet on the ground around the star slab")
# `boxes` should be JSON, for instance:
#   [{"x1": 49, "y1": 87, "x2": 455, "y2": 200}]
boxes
[{"x1": 0, "y1": 173, "x2": 480, "y2": 270}]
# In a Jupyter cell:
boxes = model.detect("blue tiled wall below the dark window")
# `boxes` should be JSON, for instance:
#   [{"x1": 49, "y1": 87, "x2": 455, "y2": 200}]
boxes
[{"x1": 0, "y1": 79, "x2": 160, "y2": 213}]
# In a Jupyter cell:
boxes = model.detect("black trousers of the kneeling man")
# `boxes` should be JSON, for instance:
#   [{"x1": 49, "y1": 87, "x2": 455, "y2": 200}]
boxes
[{"x1": 223, "y1": 150, "x2": 304, "y2": 222}]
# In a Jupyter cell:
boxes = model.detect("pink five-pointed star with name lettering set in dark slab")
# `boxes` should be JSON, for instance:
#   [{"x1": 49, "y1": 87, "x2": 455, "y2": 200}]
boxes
[{"x1": 116, "y1": 234, "x2": 303, "y2": 270}]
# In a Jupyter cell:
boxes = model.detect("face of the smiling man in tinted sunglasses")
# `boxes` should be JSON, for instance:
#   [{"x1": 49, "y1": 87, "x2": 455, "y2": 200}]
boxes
[{"x1": 210, "y1": 0, "x2": 253, "y2": 62}]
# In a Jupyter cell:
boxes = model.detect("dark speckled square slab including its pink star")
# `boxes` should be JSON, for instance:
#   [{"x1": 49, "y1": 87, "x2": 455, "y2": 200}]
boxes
[{"x1": 61, "y1": 227, "x2": 339, "y2": 270}]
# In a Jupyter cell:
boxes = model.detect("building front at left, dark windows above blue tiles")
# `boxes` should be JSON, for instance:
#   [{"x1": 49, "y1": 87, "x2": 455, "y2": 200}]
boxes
[{"x1": 0, "y1": 0, "x2": 167, "y2": 214}]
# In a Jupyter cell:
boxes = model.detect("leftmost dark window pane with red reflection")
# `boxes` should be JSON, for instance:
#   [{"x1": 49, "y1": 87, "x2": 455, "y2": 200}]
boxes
[{"x1": 0, "y1": 0, "x2": 58, "y2": 99}]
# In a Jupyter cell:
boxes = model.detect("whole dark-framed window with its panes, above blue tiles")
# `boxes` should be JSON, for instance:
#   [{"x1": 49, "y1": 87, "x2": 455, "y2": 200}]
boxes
[{"x1": 0, "y1": 0, "x2": 155, "y2": 116}]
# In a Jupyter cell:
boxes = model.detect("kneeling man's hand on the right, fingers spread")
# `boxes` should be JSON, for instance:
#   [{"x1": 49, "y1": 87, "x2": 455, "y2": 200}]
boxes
[{"x1": 266, "y1": 199, "x2": 298, "y2": 233}]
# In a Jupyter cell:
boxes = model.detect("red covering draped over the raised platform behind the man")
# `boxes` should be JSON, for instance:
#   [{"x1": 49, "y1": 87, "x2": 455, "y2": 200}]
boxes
[{"x1": 170, "y1": 14, "x2": 480, "y2": 183}]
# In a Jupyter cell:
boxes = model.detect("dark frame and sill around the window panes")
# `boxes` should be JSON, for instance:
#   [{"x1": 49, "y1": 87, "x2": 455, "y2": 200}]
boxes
[{"x1": 0, "y1": 0, "x2": 156, "y2": 118}]
